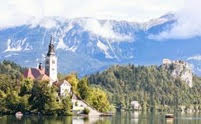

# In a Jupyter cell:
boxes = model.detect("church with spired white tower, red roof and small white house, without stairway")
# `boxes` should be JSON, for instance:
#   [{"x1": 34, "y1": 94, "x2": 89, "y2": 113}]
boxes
[{"x1": 24, "y1": 37, "x2": 71, "y2": 96}]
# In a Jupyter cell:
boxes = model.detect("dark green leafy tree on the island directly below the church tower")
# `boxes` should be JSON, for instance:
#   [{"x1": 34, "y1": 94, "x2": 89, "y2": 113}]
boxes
[{"x1": 29, "y1": 81, "x2": 62, "y2": 114}]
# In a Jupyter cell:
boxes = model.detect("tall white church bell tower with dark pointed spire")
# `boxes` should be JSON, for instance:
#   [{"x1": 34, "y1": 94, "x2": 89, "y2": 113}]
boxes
[{"x1": 45, "y1": 37, "x2": 57, "y2": 85}]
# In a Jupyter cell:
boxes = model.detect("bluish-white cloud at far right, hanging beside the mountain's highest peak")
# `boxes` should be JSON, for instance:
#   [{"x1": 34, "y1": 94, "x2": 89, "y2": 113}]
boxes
[{"x1": 150, "y1": 0, "x2": 201, "y2": 40}]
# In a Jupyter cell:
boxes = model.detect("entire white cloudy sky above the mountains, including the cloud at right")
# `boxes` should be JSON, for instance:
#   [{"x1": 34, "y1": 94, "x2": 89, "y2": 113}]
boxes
[{"x1": 0, "y1": 0, "x2": 201, "y2": 40}]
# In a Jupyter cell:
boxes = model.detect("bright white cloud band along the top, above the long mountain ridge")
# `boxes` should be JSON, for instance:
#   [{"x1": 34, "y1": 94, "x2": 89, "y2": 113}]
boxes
[{"x1": 0, "y1": 0, "x2": 184, "y2": 28}]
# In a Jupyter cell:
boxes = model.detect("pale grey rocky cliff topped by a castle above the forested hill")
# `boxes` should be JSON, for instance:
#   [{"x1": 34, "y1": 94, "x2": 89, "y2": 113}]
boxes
[{"x1": 162, "y1": 59, "x2": 193, "y2": 87}]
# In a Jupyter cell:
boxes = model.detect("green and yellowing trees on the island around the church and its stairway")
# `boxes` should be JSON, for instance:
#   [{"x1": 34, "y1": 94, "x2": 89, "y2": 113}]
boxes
[{"x1": 0, "y1": 61, "x2": 112, "y2": 115}]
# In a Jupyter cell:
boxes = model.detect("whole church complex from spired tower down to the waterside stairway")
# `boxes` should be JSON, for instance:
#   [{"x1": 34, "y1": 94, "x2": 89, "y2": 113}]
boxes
[{"x1": 24, "y1": 37, "x2": 101, "y2": 115}]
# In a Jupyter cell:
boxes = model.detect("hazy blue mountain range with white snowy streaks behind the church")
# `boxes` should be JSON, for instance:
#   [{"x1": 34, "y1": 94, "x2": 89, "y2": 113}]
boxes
[{"x1": 0, "y1": 14, "x2": 201, "y2": 76}]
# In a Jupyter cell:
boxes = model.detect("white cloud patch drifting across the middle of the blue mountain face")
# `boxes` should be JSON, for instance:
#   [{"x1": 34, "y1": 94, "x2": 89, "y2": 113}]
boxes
[{"x1": 84, "y1": 19, "x2": 132, "y2": 42}]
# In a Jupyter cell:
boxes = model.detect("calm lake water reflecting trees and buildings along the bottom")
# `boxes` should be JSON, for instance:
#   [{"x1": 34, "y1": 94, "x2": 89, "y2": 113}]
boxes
[{"x1": 0, "y1": 112, "x2": 201, "y2": 124}]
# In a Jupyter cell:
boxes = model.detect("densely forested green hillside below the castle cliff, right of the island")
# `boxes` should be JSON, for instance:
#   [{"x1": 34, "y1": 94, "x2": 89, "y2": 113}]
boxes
[{"x1": 89, "y1": 65, "x2": 201, "y2": 110}]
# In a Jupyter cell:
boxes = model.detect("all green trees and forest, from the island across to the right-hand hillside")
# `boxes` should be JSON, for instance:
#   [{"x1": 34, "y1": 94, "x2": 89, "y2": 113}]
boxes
[{"x1": 0, "y1": 61, "x2": 201, "y2": 115}]
